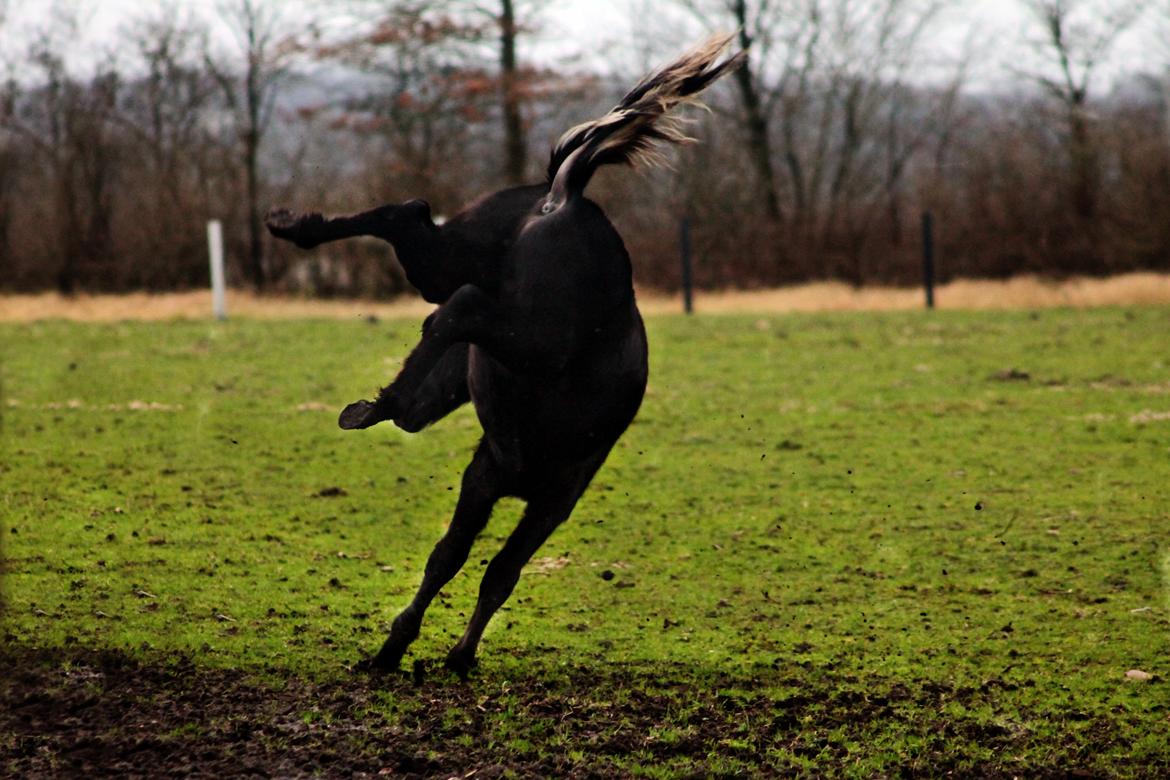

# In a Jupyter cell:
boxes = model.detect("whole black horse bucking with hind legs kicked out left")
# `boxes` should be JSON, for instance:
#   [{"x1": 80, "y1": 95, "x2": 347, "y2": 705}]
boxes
[{"x1": 267, "y1": 36, "x2": 744, "y2": 677}]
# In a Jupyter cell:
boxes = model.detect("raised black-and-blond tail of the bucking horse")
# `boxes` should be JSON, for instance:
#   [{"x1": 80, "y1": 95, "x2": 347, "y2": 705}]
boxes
[{"x1": 549, "y1": 35, "x2": 746, "y2": 205}]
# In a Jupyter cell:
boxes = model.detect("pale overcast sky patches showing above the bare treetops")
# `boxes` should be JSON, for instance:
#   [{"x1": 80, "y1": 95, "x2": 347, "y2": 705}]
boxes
[{"x1": 0, "y1": 0, "x2": 1151, "y2": 90}]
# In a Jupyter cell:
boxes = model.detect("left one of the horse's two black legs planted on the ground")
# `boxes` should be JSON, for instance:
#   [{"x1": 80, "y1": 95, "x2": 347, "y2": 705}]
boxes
[{"x1": 365, "y1": 442, "x2": 502, "y2": 671}]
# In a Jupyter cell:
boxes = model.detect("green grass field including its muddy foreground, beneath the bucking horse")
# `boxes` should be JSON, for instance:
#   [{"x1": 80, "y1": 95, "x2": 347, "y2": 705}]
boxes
[{"x1": 0, "y1": 306, "x2": 1170, "y2": 776}]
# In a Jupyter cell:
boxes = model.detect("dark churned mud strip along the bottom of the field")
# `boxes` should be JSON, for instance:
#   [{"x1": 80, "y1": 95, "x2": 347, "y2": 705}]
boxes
[{"x1": 0, "y1": 647, "x2": 1144, "y2": 778}]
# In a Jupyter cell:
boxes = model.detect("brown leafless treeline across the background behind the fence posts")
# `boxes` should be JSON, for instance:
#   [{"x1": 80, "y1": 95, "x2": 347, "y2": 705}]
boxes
[{"x1": 0, "y1": 0, "x2": 1170, "y2": 296}]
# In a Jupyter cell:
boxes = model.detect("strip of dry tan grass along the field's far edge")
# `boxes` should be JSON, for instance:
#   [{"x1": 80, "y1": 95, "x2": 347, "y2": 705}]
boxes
[{"x1": 0, "y1": 274, "x2": 1170, "y2": 322}]
